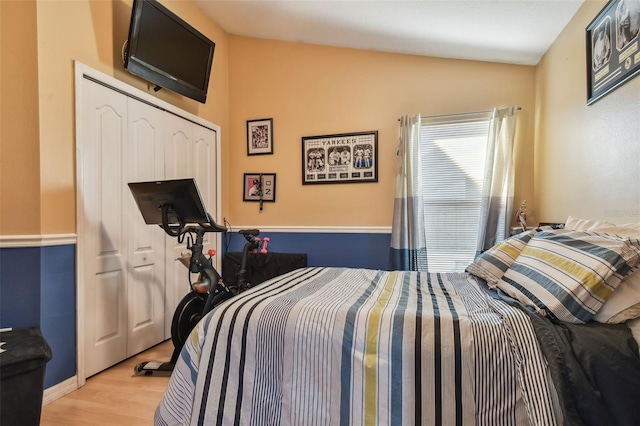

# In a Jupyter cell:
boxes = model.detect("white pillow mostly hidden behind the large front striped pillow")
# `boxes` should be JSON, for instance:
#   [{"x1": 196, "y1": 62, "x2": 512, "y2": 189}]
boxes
[{"x1": 564, "y1": 216, "x2": 640, "y2": 324}]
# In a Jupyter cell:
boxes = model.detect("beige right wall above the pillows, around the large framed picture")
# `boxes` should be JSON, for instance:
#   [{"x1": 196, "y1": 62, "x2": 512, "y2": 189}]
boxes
[{"x1": 535, "y1": 0, "x2": 640, "y2": 223}]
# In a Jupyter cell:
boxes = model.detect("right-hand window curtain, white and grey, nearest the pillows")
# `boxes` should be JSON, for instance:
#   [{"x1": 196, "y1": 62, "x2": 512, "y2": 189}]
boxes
[{"x1": 478, "y1": 107, "x2": 518, "y2": 253}]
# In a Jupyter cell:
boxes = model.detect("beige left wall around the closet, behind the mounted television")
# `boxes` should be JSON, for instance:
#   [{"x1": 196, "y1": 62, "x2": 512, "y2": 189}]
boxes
[{"x1": 0, "y1": 0, "x2": 228, "y2": 235}]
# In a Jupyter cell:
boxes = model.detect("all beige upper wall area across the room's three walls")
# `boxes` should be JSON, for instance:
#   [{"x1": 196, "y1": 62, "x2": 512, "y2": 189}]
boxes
[{"x1": 7, "y1": 0, "x2": 640, "y2": 235}]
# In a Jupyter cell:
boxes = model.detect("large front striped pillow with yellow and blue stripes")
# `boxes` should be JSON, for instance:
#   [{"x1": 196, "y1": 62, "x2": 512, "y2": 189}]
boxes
[{"x1": 497, "y1": 229, "x2": 640, "y2": 323}]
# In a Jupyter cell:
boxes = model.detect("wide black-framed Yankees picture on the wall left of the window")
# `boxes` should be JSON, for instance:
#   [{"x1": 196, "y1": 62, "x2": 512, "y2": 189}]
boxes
[{"x1": 302, "y1": 131, "x2": 378, "y2": 185}]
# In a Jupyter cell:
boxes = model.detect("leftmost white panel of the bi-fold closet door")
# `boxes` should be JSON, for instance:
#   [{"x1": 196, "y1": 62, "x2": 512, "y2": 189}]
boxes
[{"x1": 78, "y1": 82, "x2": 128, "y2": 377}]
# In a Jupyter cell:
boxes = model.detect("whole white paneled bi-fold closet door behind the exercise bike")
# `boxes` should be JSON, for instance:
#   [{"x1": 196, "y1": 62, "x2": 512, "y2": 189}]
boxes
[{"x1": 76, "y1": 70, "x2": 220, "y2": 381}]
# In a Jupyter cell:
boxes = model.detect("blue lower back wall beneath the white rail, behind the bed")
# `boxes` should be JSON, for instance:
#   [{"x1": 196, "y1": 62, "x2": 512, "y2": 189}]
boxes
[{"x1": 227, "y1": 231, "x2": 391, "y2": 270}]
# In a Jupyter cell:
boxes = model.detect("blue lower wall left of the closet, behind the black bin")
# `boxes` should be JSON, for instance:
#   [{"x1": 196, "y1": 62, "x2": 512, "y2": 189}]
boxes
[{"x1": 0, "y1": 240, "x2": 77, "y2": 388}]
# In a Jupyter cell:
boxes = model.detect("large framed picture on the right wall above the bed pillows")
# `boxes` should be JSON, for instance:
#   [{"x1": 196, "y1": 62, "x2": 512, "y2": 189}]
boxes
[{"x1": 587, "y1": 0, "x2": 640, "y2": 105}]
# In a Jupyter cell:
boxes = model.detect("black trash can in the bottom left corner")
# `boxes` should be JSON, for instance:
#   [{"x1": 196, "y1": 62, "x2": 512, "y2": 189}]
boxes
[{"x1": 0, "y1": 327, "x2": 51, "y2": 426}]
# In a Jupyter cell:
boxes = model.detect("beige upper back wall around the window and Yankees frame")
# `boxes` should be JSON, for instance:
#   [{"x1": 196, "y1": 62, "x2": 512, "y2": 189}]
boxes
[{"x1": 226, "y1": 36, "x2": 535, "y2": 226}]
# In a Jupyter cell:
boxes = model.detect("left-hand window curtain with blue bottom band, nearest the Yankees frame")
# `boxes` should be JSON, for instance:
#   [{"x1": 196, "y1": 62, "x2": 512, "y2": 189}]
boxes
[{"x1": 389, "y1": 114, "x2": 427, "y2": 271}]
